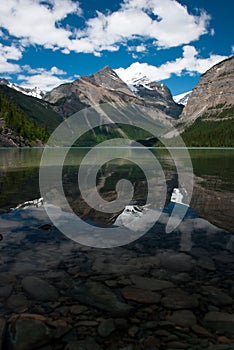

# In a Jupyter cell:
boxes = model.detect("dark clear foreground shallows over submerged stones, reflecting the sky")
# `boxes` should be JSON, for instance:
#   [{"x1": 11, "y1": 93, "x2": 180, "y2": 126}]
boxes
[{"x1": 0, "y1": 204, "x2": 234, "y2": 350}]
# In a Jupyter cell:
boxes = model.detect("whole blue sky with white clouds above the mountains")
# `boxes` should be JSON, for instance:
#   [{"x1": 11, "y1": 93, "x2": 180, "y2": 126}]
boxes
[{"x1": 0, "y1": 0, "x2": 234, "y2": 95}]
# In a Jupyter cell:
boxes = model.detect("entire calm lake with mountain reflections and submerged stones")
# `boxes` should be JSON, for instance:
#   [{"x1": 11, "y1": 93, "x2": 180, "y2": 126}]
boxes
[{"x1": 0, "y1": 148, "x2": 234, "y2": 350}]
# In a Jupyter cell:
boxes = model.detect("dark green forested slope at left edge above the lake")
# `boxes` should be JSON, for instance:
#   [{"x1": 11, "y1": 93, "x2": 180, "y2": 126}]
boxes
[{"x1": 0, "y1": 84, "x2": 63, "y2": 147}]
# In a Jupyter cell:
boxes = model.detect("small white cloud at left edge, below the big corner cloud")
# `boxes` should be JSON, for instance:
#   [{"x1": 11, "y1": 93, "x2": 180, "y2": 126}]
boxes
[{"x1": 0, "y1": 43, "x2": 22, "y2": 73}]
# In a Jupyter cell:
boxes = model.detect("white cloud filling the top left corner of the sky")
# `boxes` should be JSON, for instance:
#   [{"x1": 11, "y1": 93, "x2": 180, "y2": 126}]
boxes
[{"x1": 0, "y1": 0, "x2": 81, "y2": 48}]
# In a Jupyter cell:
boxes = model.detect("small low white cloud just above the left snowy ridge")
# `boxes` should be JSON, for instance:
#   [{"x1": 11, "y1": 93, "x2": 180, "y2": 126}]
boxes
[{"x1": 18, "y1": 66, "x2": 74, "y2": 91}]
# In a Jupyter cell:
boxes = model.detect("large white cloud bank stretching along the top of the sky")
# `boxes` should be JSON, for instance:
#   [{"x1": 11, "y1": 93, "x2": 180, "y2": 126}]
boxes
[{"x1": 0, "y1": 0, "x2": 209, "y2": 55}]
